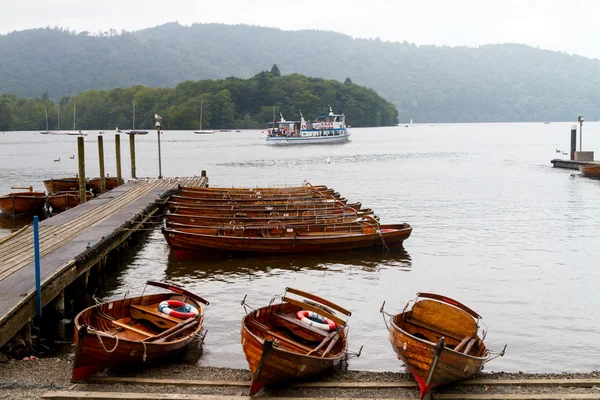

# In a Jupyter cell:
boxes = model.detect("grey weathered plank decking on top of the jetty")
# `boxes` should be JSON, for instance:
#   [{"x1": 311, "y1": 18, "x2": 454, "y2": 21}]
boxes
[{"x1": 0, "y1": 177, "x2": 206, "y2": 346}]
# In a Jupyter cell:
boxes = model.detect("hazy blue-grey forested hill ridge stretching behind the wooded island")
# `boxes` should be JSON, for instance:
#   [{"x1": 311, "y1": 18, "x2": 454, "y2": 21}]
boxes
[{"x1": 0, "y1": 23, "x2": 600, "y2": 122}]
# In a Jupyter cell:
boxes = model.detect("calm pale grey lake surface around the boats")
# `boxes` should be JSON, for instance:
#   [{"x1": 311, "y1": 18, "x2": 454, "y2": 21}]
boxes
[{"x1": 0, "y1": 122, "x2": 600, "y2": 372}]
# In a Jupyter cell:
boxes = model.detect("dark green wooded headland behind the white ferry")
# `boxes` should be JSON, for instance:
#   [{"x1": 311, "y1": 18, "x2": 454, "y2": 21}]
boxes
[{"x1": 0, "y1": 65, "x2": 398, "y2": 131}]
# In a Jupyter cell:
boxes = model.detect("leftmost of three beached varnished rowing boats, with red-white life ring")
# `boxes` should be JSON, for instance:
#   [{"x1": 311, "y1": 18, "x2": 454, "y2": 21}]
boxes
[{"x1": 73, "y1": 281, "x2": 208, "y2": 381}]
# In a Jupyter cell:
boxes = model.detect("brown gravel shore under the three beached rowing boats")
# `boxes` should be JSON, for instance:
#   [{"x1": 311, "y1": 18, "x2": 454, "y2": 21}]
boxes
[{"x1": 0, "y1": 357, "x2": 600, "y2": 400}]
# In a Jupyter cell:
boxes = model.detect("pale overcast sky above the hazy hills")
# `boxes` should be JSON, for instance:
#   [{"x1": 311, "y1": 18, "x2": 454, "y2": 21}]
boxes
[{"x1": 0, "y1": 0, "x2": 600, "y2": 58}]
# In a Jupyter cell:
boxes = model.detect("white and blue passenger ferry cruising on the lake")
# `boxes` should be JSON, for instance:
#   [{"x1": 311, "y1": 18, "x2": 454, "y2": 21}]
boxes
[{"x1": 267, "y1": 107, "x2": 350, "y2": 145}]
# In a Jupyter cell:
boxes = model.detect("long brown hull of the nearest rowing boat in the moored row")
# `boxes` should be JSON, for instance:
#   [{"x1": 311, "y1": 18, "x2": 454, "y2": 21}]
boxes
[{"x1": 163, "y1": 224, "x2": 412, "y2": 254}]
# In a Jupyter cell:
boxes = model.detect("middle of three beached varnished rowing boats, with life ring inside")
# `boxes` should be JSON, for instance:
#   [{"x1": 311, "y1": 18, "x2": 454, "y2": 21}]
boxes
[{"x1": 241, "y1": 288, "x2": 352, "y2": 396}]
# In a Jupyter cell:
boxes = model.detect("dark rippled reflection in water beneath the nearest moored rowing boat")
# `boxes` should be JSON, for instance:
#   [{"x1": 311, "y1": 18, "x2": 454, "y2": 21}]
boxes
[{"x1": 166, "y1": 246, "x2": 412, "y2": 280}]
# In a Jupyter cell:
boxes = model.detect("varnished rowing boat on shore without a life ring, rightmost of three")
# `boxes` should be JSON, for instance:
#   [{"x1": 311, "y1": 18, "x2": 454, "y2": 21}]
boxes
[{"x1": 381, "y1": 293, "x2": 504, "y2": 398}]
